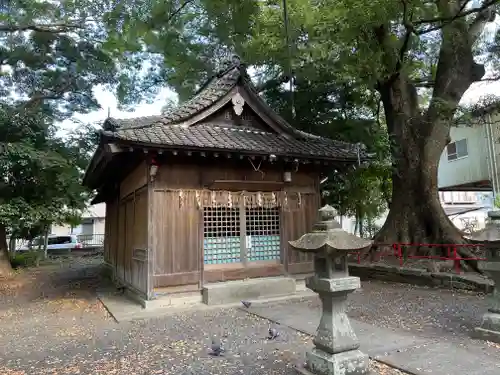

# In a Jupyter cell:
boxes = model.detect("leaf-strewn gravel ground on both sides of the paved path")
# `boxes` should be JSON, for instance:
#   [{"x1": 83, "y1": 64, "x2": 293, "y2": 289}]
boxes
[{"x1": 0, "y1": 257, "x2": 487, "y2": 375}]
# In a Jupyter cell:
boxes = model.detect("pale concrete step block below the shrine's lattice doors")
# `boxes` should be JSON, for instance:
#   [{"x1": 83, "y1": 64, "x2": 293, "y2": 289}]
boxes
[{"x1": 202, "y1": 277, "x2": 296, "y2": 305}]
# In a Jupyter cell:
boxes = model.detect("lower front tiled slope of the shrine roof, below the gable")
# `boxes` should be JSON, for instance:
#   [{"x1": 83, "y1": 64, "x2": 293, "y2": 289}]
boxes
[{"x1": 103, "y1": 124, "x2": 365, "y2": 159}]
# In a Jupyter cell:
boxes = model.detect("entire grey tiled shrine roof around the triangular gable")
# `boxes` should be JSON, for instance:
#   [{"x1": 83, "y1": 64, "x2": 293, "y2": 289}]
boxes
[{"x1": 99, "y1": 60, "x2": 366, "y2": 159}]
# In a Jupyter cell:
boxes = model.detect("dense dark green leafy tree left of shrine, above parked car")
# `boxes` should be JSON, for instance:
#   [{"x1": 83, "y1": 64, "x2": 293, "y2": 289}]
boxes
[{"x1": 0, "y1": 108, "x2": 93, "y2": 235}]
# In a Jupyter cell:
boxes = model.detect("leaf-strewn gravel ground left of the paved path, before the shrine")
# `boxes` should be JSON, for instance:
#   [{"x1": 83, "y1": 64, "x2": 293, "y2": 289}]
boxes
[{"x1": 0, "y1": 258, "x2": 410, "y2": 375}]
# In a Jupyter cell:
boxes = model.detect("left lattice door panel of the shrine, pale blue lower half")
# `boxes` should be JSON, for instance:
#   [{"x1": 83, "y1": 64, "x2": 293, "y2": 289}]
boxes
[{"x1": 203, "y1": 207, "x2": 241, "y2": 264}]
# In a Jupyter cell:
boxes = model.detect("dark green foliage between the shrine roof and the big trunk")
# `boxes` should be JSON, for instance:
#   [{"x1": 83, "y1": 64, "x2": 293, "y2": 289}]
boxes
[{"x1": 263, "y1": 69, "x2": 391, "y2": 221}]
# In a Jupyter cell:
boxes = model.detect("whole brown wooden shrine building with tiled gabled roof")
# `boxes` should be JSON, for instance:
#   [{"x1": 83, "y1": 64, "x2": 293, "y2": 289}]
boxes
[{"x1": 84, "y1": 59, "x2": 366, "y2": 299}]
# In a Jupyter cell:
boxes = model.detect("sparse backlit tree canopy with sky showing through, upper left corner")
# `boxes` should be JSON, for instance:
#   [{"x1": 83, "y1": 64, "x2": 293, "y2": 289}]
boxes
[{"x1": 0, "y1": 0, "x2": 117, "y2": 119}]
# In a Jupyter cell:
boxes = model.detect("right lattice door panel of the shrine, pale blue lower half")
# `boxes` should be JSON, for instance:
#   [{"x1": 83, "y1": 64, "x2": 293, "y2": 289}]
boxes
[{"x1": 246, "y1": 207, "x2": 281, "y2": 262}]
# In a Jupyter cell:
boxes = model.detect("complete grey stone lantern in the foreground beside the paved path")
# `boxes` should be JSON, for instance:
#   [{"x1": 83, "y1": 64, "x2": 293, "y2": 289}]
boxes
[{"x1": 289, "y1": 205, "x2": 372, "y2": 375}]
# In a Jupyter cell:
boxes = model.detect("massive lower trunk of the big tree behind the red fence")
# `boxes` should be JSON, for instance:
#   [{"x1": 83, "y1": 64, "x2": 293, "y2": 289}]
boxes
[{"x1": 374, "y1": 79, "x2": 479, "y2": 272}]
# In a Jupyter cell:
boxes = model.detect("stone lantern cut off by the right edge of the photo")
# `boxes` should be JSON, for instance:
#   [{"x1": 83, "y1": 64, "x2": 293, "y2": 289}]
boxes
[{"x1": 469, "y1": 211, "x2": 500, "y2": 343}]
